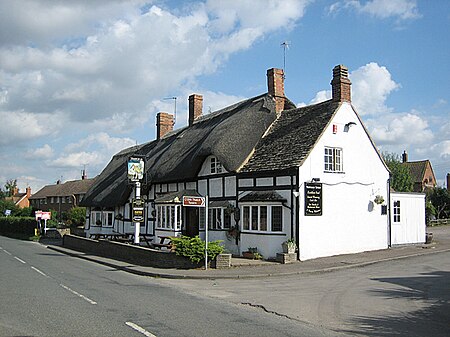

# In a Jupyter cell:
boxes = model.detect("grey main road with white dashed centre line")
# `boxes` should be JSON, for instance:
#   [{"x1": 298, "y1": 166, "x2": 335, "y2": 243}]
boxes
[{"x1": 0, "y1": 236, "x2": 337, "y2": 337}]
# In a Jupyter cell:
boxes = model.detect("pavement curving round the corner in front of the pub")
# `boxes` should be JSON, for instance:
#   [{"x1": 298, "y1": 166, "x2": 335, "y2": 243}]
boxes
[{"x1": 41, "y1": 226, "x2": 450, "y2": 279}]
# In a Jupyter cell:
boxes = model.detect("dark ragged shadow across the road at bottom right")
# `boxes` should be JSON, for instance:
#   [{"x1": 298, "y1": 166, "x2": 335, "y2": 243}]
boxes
[{"x1": 347, "y1": 272, "x2": 450, "y2": 337}]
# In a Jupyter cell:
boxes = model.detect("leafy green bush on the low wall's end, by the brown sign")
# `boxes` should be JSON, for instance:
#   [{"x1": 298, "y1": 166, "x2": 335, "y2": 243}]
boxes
[{"x1": 172, "y1": 235, "x2": 224, "y2": 263}]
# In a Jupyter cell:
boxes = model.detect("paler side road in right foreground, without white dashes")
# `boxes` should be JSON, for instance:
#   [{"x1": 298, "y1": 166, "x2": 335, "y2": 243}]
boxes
[{"x1": 159, "y1": 252, "x2": 450, "y2": 337}]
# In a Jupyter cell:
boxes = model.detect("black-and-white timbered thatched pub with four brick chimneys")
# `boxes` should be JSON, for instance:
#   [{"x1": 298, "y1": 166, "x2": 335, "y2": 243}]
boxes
[{"x1": 82, "y1": 65, "x2": 425, "y2": 260}]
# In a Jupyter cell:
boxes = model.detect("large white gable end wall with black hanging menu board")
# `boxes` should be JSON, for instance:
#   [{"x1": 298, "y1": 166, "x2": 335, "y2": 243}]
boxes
[{"x1": 299, "y1": 103, "x2": 389, "y2": 260}]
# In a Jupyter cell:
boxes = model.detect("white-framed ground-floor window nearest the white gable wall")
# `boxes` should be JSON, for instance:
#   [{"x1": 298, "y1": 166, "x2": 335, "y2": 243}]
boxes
[{"x1": 242, "y1": 205, "x2": 283, "y2": 232}]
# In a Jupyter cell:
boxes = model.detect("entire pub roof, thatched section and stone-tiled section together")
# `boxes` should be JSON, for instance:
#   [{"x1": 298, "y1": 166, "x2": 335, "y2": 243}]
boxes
[{"x1": 81, "y1": 94, "x2": 339, "y2": 207}]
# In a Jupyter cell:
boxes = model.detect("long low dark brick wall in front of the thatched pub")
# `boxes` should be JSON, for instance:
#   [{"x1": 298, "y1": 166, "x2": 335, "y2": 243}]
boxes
[{"x1": 63, "y1": 235, "x2": 202, "y2": 269}]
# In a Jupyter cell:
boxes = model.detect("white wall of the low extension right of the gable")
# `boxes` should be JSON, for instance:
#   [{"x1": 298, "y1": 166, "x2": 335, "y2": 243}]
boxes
[{"x1": 390, "y1": 192, "x2": 426, "y2": 245}]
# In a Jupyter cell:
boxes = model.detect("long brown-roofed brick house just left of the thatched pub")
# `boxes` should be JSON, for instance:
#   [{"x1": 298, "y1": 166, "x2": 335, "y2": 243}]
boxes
[{"x1": 30, "y1": 174, "x2": 95, "y2": 217}]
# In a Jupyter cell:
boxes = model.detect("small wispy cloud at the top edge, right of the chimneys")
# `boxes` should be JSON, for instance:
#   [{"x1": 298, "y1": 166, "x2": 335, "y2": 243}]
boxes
[{"x1": 328, "y1": 0, "x2": 421, "y2": 20}]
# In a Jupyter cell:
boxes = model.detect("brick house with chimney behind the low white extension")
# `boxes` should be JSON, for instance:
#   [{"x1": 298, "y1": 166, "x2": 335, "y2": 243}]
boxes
[{"x1": 402, "y1": 151, "x2": 436, "y2": 192}]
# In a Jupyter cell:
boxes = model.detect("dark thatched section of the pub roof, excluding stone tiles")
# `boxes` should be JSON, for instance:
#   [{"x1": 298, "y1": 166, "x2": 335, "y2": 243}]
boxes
[{"x1": 82, "y1": 94, "x2": 302, "y2": 207}]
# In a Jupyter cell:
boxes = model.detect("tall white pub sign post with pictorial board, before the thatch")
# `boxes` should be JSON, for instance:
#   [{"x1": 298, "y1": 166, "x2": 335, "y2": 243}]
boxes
[{"x1": 128, "y1": 157, "x2": 144, "y2": 245}]
